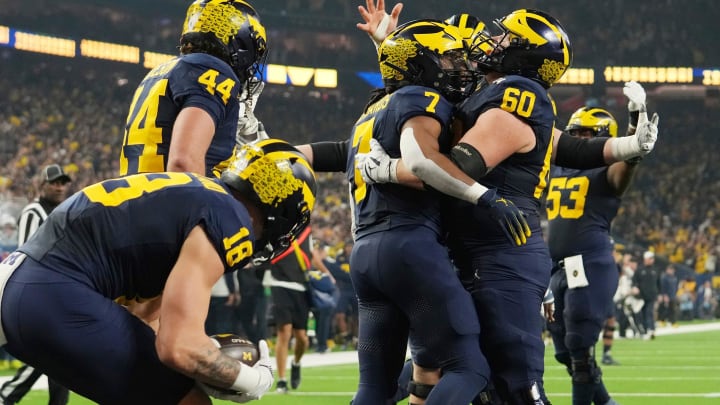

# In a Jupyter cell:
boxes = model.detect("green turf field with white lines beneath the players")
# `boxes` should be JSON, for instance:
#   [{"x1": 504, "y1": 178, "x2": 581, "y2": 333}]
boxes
[{"x1": 7, "y1": 331, "x2": 720, "y2": 405}]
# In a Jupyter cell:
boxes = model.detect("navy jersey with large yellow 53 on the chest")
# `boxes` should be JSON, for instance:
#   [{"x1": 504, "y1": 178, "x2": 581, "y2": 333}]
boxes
[{"x1": 546, "y1": 166, "x2": 621, "y2": 261}]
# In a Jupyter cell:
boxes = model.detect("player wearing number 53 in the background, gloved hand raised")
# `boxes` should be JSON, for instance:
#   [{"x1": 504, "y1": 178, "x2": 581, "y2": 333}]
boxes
[{"x1": 546, "y1": 82, "x2": 646, "y2": 405}]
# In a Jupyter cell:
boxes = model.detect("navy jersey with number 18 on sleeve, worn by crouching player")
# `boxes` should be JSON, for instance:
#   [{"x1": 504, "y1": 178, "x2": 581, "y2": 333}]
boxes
[{"x1": 19, "y1": 173, "x2": 255, "y2": 303}]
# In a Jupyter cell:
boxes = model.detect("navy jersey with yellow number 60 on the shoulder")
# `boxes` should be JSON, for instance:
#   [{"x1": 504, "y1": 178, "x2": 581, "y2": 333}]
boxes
[{"x1": 448, "y1": 75, "x2": 555, "y2": 244}]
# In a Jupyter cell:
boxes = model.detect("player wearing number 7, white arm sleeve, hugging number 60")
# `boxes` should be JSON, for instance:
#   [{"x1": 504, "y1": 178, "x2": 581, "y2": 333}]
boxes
[{"x1": 345, "y1": 20, "x2": 521, "y2": 405}]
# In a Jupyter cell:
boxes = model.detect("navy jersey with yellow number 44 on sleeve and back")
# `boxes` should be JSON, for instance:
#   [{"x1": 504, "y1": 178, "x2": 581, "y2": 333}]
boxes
[{"x1": 120, "y1": 53, "x2": 242, "y2": 176}]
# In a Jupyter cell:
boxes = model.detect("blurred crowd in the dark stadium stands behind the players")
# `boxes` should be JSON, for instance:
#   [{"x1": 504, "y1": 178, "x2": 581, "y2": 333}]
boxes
[{"x1": 0, "y1": 0, "x2": 720, "y2": 312}]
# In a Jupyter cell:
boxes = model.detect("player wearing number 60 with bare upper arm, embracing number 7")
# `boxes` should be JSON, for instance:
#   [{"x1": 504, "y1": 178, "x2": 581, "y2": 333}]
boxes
[{"x1": 354, "y1": 10, "x2": 657, "y2": 404}]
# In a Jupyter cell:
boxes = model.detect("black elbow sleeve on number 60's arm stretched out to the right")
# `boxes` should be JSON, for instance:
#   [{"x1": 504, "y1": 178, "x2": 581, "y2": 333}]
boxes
[{"x1": 555, "y1": 135, "x2": 610, "y2": 170}]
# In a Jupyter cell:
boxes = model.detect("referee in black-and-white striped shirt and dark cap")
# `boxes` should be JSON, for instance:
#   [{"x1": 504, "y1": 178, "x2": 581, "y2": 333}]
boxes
[{"x1": 0, "y1": 164, "x2": 72, "y2": 405}]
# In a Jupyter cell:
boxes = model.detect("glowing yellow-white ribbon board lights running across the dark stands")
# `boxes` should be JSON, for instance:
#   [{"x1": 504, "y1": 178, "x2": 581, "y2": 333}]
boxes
[{"x1": 0, "y1": 25, "x2": 720, "y2": 88}]
